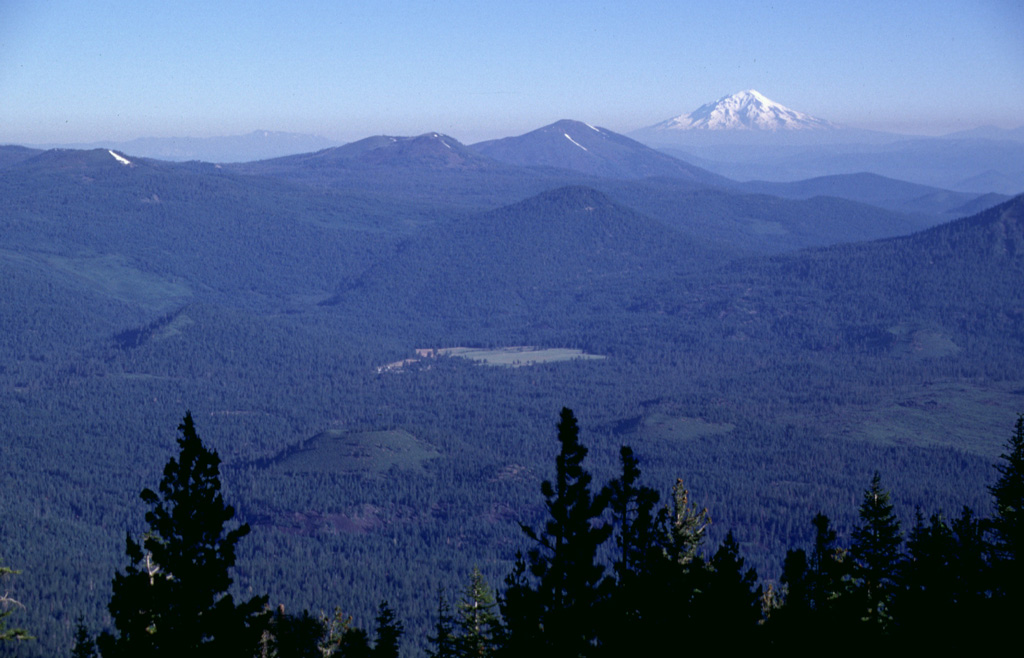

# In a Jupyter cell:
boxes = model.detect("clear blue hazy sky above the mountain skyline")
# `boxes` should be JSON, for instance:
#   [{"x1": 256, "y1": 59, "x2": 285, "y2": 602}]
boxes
[{"x1": 0, "y1": 0, "x2": 1024, "y2": 143}]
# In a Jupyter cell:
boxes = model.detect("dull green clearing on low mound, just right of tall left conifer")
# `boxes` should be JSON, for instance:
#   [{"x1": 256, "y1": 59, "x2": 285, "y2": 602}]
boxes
[{"x1": 276, "y1": 430, "x2": 440, "y2": 474}]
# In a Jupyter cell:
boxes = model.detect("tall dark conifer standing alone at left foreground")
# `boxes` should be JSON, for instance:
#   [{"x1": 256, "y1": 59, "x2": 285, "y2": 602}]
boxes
[{"x1": 98, "y1": 413, "x2": 266, "y2": 658}]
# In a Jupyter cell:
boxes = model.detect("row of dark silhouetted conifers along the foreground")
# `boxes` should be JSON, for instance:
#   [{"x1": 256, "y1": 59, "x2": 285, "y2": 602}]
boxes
[{"x1": 6, "y1": 408, "x2": 1024, "y2": 657}]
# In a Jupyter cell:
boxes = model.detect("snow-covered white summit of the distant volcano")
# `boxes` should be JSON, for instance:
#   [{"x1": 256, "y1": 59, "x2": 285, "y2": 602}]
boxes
[{"x1": 651, "y1": 89, "x2": 838, "y2": 132}]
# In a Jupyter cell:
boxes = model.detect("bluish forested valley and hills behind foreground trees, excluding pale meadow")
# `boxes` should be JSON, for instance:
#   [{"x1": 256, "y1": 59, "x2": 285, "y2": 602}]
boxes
[{"x1": 0, "y1": 146, "x2": 1024, "y2": 656}]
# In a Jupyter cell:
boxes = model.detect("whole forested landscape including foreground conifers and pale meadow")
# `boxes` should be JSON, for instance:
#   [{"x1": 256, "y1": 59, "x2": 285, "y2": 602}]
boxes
[{"x1": 0, "y1": 138, "x2": 1024, "y2": 658}]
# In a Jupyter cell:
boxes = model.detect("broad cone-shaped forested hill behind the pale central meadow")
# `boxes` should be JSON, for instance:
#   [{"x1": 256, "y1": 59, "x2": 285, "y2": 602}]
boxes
[{"x1": 323, "y1": 186, "x2": 715, "y2": 341}]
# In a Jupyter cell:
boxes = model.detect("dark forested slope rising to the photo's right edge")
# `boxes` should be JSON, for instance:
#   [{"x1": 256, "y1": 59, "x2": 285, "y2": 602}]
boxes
[{"x1": 708, "y1": 196, "x2": 1024, "y2": 360}]
